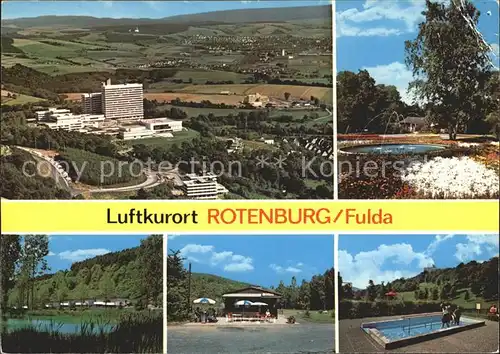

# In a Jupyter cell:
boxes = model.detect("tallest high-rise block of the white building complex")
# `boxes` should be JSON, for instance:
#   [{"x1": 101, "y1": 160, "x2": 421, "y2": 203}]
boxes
[{"x1": 102, "y1": 79, "x2": 144, "y2": 119}]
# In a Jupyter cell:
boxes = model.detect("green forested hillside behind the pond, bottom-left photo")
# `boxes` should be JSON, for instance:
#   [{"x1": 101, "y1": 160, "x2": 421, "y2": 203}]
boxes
[{"x1": 9, "y1": 236, "x2": 163, "y2": 306}]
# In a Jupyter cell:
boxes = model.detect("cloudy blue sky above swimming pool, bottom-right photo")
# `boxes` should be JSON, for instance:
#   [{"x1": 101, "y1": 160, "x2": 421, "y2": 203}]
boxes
[{"x1": 338, "y1": 234, "x2": 498, "y2": 289}]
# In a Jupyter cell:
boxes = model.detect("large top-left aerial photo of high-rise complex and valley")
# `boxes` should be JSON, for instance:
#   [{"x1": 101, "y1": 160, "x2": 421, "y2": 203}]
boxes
[{"x1": 0, "y1": 1, "x2": 335, "y2": 200}]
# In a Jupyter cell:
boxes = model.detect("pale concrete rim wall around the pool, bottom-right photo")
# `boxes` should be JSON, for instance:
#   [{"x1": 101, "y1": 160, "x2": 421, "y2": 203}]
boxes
[{"x1": 361, "y1": 312, "x2": 486, "y2": 349}]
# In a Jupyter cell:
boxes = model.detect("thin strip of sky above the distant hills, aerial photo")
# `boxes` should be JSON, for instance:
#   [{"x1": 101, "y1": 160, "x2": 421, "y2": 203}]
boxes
[{"x1": 2, "y1": 0, "x2": 328, "y2": 19}]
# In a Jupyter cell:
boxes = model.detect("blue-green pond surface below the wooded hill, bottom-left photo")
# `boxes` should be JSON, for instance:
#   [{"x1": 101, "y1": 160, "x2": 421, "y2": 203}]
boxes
[{"x1": 7, "y1": 318, "x2": 115, "y2": 334}]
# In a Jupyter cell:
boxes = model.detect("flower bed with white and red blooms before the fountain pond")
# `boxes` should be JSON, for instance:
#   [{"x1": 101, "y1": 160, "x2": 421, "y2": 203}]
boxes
[{"x1": 338, "y1": 142, "x2": 499, "y2": 199}]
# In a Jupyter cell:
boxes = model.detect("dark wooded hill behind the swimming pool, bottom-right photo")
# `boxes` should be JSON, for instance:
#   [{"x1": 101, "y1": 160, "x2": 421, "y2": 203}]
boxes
[{"x1": 341, "y1": 257, "x2": 498, "y2": 300}]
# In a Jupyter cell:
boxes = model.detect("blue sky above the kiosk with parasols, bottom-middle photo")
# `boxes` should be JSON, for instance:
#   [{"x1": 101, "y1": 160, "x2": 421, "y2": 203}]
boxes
[{"x1": 167, "y1": 235, "x2": 333, "y2": 287}]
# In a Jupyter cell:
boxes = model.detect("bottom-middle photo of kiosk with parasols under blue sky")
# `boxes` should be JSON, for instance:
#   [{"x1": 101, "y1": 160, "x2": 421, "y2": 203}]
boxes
[{"x1": 166, "y1": 234, "x2": 335, "y2": 354}]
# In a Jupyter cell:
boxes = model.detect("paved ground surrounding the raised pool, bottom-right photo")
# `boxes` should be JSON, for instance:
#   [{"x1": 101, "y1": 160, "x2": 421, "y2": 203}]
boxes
[{"x1": 338, "y1": 316, "x2": 499, "y2": 353}]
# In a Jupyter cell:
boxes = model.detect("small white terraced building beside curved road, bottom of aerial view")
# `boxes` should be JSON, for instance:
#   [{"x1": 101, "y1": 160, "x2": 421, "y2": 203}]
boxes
[{"x1": 181, "y1": 173, "x2": 229, "y2": 199}]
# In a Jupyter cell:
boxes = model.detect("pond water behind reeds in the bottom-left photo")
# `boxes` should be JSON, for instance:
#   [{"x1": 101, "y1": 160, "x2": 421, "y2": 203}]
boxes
[{"x1": 3, "y1": 316, "x2": 115, "y2": 334}]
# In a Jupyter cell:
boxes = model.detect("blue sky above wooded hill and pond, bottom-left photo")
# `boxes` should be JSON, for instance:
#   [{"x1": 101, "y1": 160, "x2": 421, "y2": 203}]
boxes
[{"x1": 42, "y1": 235, "x2": 147, "y2": 273}]
